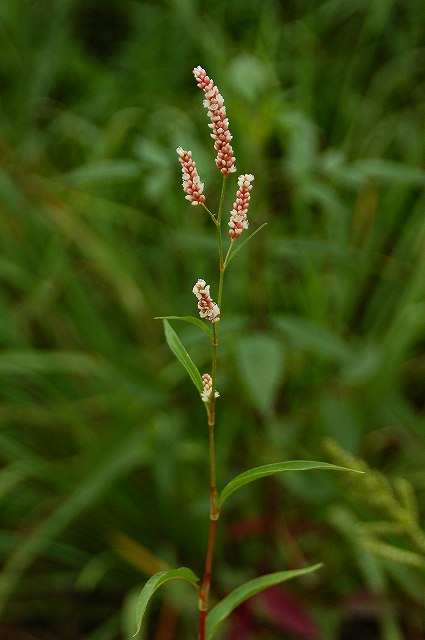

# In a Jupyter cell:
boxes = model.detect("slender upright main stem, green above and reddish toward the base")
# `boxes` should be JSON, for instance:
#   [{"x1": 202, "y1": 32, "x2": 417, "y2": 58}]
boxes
[{"x1": 199, "y1": 176, "x2": 227, "y2": 640}]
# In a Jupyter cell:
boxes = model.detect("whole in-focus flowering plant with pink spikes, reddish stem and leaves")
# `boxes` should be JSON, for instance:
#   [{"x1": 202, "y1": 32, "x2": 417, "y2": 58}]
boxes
[{"x1": 136, "y1": 67, "x2": 358, "y2": 640}]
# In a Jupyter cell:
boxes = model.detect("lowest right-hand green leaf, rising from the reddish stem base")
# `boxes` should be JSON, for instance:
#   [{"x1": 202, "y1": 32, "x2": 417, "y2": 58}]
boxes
[{"x1": 206, "y1": 564, "x2": 322, "y2": 640}]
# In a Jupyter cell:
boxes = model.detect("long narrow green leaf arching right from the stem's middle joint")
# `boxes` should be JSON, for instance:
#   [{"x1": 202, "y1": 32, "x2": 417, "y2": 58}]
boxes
[{"x1": 220, "y1": 460, "x2": 361, "y2": 505}]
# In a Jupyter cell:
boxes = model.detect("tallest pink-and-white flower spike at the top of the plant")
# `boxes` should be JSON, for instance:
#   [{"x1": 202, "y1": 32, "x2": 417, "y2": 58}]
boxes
[{"x1": 193, "y1": 67, "x2": 236, "y2": 175}]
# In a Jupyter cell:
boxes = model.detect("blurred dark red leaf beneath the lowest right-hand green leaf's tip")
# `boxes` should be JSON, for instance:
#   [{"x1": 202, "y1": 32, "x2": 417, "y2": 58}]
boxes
[{"x1": 252, "y1": 586, "x2": 320, "y2": 640}]
